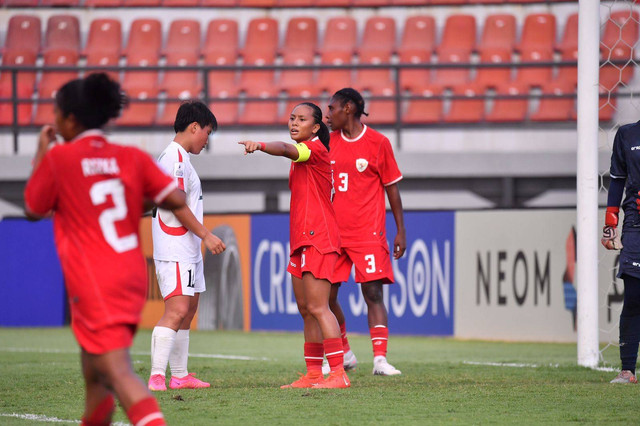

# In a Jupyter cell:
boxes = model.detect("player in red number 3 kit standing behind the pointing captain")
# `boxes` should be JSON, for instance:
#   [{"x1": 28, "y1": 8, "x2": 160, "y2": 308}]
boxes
[{"x1": 327, "y1": 88, "x2": 407, "y2": 376}]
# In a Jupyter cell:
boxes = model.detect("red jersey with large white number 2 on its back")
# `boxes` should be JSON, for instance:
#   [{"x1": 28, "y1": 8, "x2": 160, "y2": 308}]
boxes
[{"x1": 24, "y1": 130, "x2": 176, "y2": 330}]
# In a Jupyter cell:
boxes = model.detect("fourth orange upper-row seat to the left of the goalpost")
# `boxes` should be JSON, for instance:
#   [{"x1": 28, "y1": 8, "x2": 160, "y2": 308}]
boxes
[{"x1": 433, "y1": 15, "x2": 476, "y2": 87}]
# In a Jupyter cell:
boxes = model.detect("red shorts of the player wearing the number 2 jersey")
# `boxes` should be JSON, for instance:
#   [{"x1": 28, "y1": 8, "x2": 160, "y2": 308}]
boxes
[{"x1": 71, "y1": 321, "x2": 138, "y2": 355}]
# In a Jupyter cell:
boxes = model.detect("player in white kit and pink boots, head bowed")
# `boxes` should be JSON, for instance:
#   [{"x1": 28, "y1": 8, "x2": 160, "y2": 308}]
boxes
[{"x1": 148, "y1": 101, "x2": 226, "y2": 391}]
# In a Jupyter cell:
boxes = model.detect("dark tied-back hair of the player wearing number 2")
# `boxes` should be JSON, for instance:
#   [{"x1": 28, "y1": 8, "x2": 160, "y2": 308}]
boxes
[{"x1": 56, "y1": 73, "x2": 128, "y2": 129}]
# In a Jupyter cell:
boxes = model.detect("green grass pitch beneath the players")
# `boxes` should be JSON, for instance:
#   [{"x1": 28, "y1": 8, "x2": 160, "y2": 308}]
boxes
[{"x1": 0, "y1": 328, "x2": 640, "y2": 426}]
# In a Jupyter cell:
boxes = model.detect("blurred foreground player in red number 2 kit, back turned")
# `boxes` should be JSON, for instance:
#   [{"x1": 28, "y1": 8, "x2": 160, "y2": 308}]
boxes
[{"x1": 24, "y1": 74, "x2": 210, "y2": 426}]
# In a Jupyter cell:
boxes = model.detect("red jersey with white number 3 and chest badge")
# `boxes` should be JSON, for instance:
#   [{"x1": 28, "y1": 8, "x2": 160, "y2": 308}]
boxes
[{"x1": 329, "y1": 125, "x2": 402, "y2": 247}]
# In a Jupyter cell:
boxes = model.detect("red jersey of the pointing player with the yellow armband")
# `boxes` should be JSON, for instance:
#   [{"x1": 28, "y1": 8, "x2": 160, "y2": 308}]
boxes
[{"x1": 289, "y1": 139, "x2": 340, "y2": 254}]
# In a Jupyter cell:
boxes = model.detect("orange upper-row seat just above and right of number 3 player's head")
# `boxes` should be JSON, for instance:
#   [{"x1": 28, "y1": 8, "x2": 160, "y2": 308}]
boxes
[{"x1": 354, "y1": 17, "x2": 396, "y2": 90}]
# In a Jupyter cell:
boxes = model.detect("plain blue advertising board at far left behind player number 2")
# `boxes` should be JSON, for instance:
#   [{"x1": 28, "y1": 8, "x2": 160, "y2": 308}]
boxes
[{"x1": 0, "y1": 219, "x2": 66, "y2": 327}]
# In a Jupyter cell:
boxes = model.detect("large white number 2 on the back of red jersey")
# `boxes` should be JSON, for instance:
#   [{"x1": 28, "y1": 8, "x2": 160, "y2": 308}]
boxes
[{"x1": 89, "y1": 179, "x2": 138, "y2": 253}]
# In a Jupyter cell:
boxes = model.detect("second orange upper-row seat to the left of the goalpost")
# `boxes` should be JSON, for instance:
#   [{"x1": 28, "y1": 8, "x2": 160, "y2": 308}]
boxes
[{"x1": 516, "y1": 13, "x2": 556, "y2": 87}]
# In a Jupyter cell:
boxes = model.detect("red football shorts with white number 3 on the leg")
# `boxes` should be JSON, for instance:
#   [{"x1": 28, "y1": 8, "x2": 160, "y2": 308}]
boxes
[{"x1": 334, "y1": 245, "x2": 394, "y2": 284}]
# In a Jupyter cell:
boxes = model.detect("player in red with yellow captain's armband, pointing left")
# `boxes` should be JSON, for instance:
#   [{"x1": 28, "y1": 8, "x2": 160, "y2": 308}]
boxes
[{"x1": 239, "y1": 102, "x2": 351, "y2": 388}]
